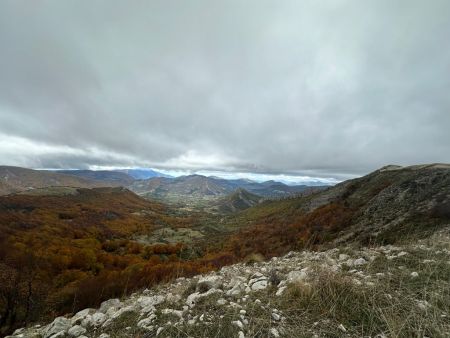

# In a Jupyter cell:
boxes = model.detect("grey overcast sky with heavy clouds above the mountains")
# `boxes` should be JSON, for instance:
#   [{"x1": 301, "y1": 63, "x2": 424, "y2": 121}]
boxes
[{"x1": 0, "y1": 0, "x2": 450, "y2": 179}]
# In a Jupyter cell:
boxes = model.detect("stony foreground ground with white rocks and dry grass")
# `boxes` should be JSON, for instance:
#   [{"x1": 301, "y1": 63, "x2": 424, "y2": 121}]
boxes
[{"x1": 10, "y1": 230, "x2": 450, "y2": 338}]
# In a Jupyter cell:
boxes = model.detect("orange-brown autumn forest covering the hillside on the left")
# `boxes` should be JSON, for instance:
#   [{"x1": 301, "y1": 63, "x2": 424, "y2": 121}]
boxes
[{"x1": 0, "y1": 188, "x2": 207, "y2": 334}]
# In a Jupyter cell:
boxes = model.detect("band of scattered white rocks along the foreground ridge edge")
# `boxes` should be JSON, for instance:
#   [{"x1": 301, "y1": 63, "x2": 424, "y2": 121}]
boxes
[{"x1": 12, "y1": 239, "x2": 450, "y2": 338}]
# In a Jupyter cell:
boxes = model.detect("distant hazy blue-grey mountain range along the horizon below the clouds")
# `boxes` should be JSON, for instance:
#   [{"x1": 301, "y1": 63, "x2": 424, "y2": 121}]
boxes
[{"x1": 0, "y1": 166, "x2": 325, "y2": 205}]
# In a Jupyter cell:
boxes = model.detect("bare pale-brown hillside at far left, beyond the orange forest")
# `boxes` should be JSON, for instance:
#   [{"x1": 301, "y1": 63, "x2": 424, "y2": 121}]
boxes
[{"x1": 0, "y1": 166, "x2": 106, "y2": 195}]
